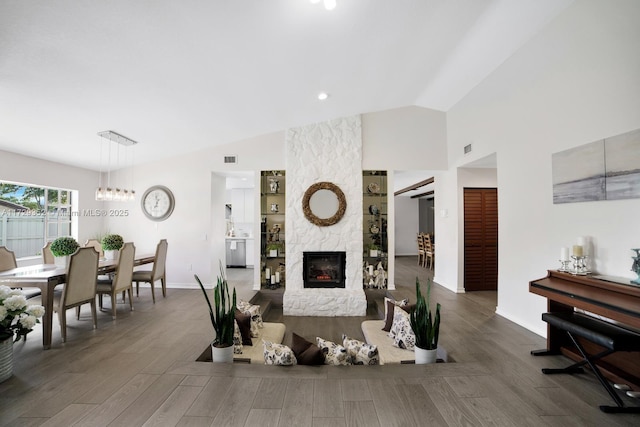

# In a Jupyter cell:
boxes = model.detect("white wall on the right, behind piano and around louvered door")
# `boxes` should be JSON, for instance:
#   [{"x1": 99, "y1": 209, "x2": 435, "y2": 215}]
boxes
[{"x1": 444, "y1": 0, "x2": 640, "y2": 335}]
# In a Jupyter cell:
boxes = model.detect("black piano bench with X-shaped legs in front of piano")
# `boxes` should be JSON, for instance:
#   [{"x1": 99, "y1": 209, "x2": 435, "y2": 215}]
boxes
[{"x1": 542, "y1": 312, "x2": 640, "y2": 413}]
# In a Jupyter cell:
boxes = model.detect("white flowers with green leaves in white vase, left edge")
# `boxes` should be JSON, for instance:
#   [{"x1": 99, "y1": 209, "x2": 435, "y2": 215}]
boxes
[{"x1": 0, "y1": 285, "x2": 44, "y2": 383}]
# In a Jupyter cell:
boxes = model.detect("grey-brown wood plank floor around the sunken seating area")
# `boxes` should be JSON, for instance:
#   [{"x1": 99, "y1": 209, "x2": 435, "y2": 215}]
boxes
[{"x1": 0, "y1": 257, "x2": 640, "y2": 427}]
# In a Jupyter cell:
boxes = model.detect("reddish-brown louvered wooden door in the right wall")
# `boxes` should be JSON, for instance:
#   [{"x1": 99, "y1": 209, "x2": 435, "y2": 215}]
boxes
[{"x1": 464, "y1": 188, "x2": 498, "y2": 291}]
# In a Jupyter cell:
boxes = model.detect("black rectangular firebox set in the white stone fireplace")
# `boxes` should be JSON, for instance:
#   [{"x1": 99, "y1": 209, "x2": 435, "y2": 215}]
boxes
[{"x1": 302, "y1": 252, "x2": 347, "y2": 288}]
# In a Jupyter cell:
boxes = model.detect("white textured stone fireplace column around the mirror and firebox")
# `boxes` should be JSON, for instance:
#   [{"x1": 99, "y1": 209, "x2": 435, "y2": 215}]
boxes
[{"x1": 282, "y1": 116, "x2": 367, "y2": 316}]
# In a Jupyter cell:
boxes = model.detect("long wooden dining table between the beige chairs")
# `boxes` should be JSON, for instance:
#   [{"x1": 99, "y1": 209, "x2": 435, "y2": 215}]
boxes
[{"x1": 0, "y1": 254, "x2": 155, "y2": 350}]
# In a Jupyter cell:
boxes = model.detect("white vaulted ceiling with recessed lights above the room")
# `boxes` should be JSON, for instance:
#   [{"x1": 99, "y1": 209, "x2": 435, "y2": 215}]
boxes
[{"x1": 0, "y1": 0, "x2": 572, "y2": 169}]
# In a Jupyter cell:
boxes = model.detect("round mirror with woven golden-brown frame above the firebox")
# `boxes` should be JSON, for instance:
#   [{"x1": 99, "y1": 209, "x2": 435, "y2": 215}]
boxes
[{"x1": 302, "y1": 182, "x2": 347, "y2": 227}]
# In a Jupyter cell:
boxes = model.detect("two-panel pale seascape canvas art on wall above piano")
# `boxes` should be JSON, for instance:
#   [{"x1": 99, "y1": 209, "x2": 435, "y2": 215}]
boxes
[{"x1": 552, "y1": 129, "x2": 640, "y2": 204}]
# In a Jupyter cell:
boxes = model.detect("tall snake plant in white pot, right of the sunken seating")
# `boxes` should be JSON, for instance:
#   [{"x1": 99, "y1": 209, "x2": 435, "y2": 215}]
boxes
[{"x1": 409, "y1": 277, "x2": 440, "y2": 364}]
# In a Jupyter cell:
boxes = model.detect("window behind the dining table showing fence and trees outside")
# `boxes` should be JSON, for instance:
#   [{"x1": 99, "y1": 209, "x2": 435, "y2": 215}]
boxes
[{"x1": 0, "y1": 182, "x2": 75, "y2": 258}]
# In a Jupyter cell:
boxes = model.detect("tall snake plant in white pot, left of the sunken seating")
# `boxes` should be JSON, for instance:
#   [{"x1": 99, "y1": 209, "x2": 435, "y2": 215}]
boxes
[{"x1": 194, "y1": 263, "x2": 236, "y2": 363}]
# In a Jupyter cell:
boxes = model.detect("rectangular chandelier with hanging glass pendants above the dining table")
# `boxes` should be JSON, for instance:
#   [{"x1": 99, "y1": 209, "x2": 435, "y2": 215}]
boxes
[{"x1": 96, "y1": 130, "x2": 137, "y2": 202}]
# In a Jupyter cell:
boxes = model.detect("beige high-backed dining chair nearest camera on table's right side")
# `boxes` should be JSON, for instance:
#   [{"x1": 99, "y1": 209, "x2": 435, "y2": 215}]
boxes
[{"x1": 53, "y1": 248, "x2": 99, "y2": 342}]
